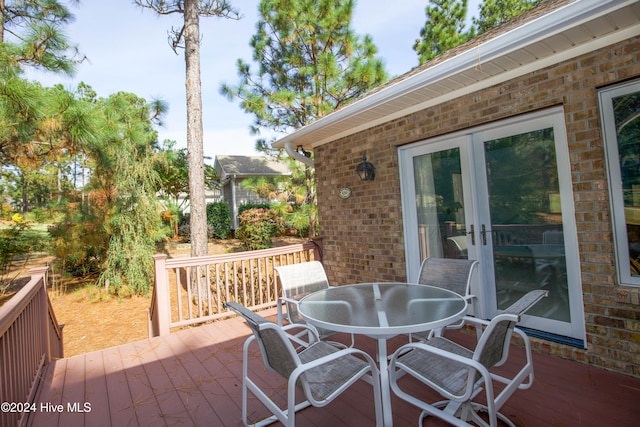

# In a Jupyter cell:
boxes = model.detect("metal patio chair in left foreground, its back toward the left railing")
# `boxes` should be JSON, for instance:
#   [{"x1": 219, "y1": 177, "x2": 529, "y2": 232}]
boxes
[{"x1": 225, "y1": 302, "x2": 382, "y2": 426}]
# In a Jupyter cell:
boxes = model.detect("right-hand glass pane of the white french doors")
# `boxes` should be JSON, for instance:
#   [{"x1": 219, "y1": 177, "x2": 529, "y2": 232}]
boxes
[{"x1": 485, "y1": 128, "x2": 570, "y2": 321}]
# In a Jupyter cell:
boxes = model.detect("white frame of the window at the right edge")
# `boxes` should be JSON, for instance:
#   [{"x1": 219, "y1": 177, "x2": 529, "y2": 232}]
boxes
[{"x1": 598, "y1": 80, "x2": 640, "y2": 287}]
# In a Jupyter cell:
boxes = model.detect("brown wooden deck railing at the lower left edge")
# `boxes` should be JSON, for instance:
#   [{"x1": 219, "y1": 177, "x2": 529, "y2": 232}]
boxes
[{"x1": 0, "y1": 267, "x2": 63, "y2": 426}]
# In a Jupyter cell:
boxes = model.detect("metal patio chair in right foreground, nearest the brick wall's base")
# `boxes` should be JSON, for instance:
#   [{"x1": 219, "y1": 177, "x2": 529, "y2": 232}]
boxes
[{"x1": 389, "y1": 290, "x2": 548, "y2": 427}]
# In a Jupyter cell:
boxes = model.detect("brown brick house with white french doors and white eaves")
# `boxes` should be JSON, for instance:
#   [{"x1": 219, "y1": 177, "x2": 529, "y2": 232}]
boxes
[{"x1": 274, "y1": 0, "x2": 640, "y2": 376}]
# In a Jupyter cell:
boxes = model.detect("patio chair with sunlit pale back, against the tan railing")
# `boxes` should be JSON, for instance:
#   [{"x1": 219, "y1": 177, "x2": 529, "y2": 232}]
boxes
[{"x1": 275, "y1": 261, "x2": 354, "y2": 347}]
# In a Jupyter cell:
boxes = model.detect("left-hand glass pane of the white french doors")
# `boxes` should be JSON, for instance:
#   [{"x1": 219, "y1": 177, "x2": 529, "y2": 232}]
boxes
[{"x1": 413, "y1": 148, "x2": 467, "y2": 261}]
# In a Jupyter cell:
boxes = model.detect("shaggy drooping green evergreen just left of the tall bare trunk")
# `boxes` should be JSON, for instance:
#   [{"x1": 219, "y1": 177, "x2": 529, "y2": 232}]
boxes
[{"x1": 91, "y1": 92, "x2": 162, "y2": 294}]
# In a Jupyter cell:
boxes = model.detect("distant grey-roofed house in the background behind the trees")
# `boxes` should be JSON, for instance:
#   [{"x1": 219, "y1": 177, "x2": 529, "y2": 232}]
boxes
[{"x1": 213, "y1": 156, "x2": 291, "y2": 230}]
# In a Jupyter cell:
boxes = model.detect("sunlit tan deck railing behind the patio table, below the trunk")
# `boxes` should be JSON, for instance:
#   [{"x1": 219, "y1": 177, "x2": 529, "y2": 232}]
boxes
[{"x1": 148, "y1": 241, "x2": 321, "y2": 337}]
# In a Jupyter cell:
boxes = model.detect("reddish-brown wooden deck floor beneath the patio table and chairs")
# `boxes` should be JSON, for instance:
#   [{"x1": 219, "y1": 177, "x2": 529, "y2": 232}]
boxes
[{"x1": 27, "y1": 311, "x2": 640, "y2": 427}]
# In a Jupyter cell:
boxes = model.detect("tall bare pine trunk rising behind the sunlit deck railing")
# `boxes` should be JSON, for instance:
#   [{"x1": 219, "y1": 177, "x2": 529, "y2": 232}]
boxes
[{"x1": 184, "y1": 0, "x2": 207, "y2": 256}]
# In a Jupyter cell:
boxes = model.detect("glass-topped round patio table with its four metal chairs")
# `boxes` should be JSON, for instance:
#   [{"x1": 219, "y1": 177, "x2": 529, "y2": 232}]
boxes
[{"x1": 226, "y1": 259, "x2": 547, "y2": 427}]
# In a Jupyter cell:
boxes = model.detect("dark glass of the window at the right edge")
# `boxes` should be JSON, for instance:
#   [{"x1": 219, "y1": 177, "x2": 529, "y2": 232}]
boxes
[{"x1": 613, "y1": 92, "x2": 640, "y2": 276}]
